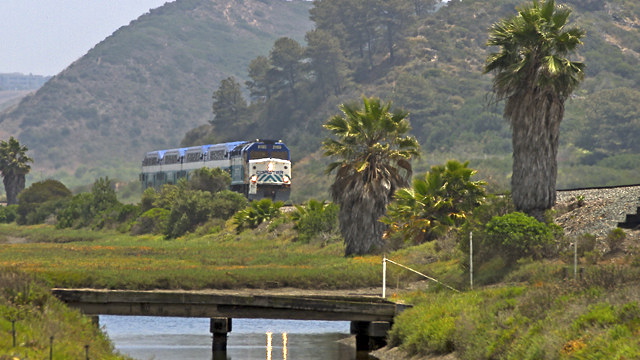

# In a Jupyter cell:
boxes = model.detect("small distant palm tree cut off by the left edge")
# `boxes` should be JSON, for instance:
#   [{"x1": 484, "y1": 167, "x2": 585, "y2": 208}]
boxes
[{"x1": 0, "y1": 136, "x2": 33, "y2": 205}]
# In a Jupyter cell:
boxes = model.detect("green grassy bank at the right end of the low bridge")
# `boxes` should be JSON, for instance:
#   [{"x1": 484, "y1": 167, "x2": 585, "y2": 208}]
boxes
[{"x1": 389, "y1": 263, "x2": 640, "y2": 360}]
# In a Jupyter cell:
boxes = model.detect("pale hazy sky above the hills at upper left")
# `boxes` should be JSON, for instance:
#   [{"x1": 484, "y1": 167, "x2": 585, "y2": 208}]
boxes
[{"x1": 0, "y1": 0, "x2": 173, "y2": 75}]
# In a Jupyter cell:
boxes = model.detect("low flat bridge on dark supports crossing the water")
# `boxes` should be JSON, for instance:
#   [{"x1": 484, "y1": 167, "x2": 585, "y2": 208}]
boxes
[{"x1": 52, "y1": 289, "x2": 407, "y2": 359}]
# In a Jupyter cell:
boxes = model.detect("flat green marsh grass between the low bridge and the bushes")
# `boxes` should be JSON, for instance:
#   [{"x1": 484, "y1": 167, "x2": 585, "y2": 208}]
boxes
[{"x1": 0, "y1": 225, "x2": 382, "y2": 289}]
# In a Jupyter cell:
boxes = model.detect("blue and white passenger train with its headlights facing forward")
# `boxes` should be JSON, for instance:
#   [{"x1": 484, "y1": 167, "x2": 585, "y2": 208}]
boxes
[{"x1": 140, "y1": 140, "x2": 291, "y2": 201}]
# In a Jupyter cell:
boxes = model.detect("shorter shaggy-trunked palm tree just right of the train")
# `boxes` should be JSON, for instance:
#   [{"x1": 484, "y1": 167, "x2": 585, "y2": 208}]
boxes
[{"x1": 322, "y1": 97, "x2": 420, "y2": 256}]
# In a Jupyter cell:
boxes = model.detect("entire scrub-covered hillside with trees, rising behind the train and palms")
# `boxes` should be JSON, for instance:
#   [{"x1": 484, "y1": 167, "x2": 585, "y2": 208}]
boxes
[{"x1": 0, "y1": 0, "x2": 640, "y2": 197}]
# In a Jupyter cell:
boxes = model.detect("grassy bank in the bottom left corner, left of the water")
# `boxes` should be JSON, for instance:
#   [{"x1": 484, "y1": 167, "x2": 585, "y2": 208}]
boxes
[{"x1": 0, "y1": 268, "x2": 128, "y2": 360}]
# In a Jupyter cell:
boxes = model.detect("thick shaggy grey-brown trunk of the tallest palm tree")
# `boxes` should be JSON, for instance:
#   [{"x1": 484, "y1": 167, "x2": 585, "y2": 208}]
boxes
[{"x1": 507, "y1": 91, "x2": 564, "y2": 221}]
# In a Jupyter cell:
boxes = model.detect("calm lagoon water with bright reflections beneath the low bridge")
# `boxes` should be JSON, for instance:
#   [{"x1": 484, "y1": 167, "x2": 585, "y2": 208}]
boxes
[{"x1": 100, "y1": 316, "x2": 370, "y2": 360}]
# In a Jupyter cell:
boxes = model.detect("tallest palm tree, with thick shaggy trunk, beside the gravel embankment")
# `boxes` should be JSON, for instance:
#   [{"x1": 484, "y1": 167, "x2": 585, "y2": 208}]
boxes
[{"x1": 485, "y1": 0, "x2": 585, "y2": 220}]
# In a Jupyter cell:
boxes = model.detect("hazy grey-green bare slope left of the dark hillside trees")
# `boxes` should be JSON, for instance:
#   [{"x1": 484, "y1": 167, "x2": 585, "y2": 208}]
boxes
[{"x1": 0, "y1": 0, "x2": 311, "y2": 181}]
